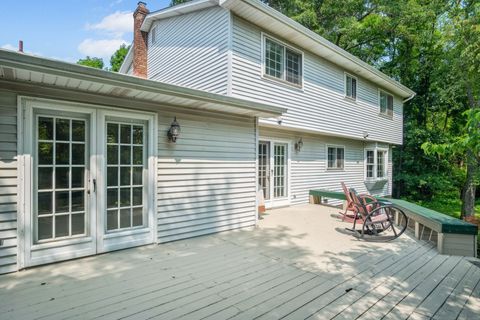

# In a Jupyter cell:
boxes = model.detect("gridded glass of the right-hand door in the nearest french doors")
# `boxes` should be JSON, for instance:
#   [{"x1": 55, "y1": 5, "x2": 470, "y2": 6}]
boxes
[{"x1": 106, "y1": 121, "x2": 146, "y2": 231}]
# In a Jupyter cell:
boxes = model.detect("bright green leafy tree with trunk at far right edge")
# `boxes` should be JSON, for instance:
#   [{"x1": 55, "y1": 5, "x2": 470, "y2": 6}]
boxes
[{"x1": 422, "y1": 1, "x2": 480, "y2": 217}]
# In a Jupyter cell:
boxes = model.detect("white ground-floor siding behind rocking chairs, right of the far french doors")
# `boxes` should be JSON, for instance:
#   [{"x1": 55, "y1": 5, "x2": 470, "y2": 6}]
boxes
[{"x1": 260, "y1": 127, "x2": 392, "y2": 205}]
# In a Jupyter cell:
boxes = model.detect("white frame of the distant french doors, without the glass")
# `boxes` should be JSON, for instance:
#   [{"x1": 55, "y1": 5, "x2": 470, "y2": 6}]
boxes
[{"x1": 257, "y1": 136, "x2": 292, "y2": 209}]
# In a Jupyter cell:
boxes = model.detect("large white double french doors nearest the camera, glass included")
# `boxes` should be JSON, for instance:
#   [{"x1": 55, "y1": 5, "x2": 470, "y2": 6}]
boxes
[{"x1": 21, "y1": 100, "x2": 154, "y2": 267}]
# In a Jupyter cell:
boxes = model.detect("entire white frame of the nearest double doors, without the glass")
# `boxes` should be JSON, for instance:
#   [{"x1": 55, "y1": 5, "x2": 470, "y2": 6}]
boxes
[{"x1": 17, "y1": 95, "x2": 158, "y2": 269}]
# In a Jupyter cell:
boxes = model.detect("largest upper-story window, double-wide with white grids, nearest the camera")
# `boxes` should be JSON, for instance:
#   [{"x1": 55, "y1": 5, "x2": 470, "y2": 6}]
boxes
[{"x1": 264, "y1": 37, "x2": 303, "y2": 86}]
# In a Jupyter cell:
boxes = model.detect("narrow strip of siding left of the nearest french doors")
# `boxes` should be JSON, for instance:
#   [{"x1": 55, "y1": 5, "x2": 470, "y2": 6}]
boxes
[{"x1": 0, "y1": 91, "x2": 18, "y2": 274}]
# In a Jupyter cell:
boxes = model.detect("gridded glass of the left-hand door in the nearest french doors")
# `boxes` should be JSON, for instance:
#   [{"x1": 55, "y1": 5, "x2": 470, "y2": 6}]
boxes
[{"x1": 34, "y1": 115, "x2": 88, "y2": 243}]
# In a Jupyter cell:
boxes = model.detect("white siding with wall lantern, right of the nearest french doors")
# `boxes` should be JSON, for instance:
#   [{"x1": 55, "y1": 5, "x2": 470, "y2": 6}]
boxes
[{"x1": 157, "y1": 113, "x2": 257, "y2": 242}]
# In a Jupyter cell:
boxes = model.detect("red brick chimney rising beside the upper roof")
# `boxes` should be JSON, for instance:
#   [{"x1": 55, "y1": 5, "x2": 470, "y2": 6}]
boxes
[{"x1": 133, "y1": 1, "x2": 150, "y2": 78}]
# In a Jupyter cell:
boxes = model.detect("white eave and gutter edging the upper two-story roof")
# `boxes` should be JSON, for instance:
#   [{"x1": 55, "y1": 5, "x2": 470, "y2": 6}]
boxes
[{"x1": 141, "y1": 0, "x2": 415, "y2": 99}]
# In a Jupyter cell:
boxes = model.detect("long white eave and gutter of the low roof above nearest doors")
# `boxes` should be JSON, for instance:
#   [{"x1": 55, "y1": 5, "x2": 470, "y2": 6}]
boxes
[{"x1": 0, "y1": 49, "x2": 287, "y2": 117}]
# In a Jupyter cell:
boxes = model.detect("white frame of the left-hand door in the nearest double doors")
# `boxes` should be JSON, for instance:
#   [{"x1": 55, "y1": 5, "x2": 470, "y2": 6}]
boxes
[{"x1": 18, "y1": 97, "x2": 97, "y2": 268}]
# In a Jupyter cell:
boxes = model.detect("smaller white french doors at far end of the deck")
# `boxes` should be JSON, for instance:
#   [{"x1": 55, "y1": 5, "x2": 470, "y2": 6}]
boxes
[{"x1": 258, "y1": 139, "x2": 290, "y2": 208}]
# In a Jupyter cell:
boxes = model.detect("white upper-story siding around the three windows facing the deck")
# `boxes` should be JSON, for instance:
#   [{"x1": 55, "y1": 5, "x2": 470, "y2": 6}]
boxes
[{"x1": 232, "y1": 16, "x2": 403, "y2": 144}]
